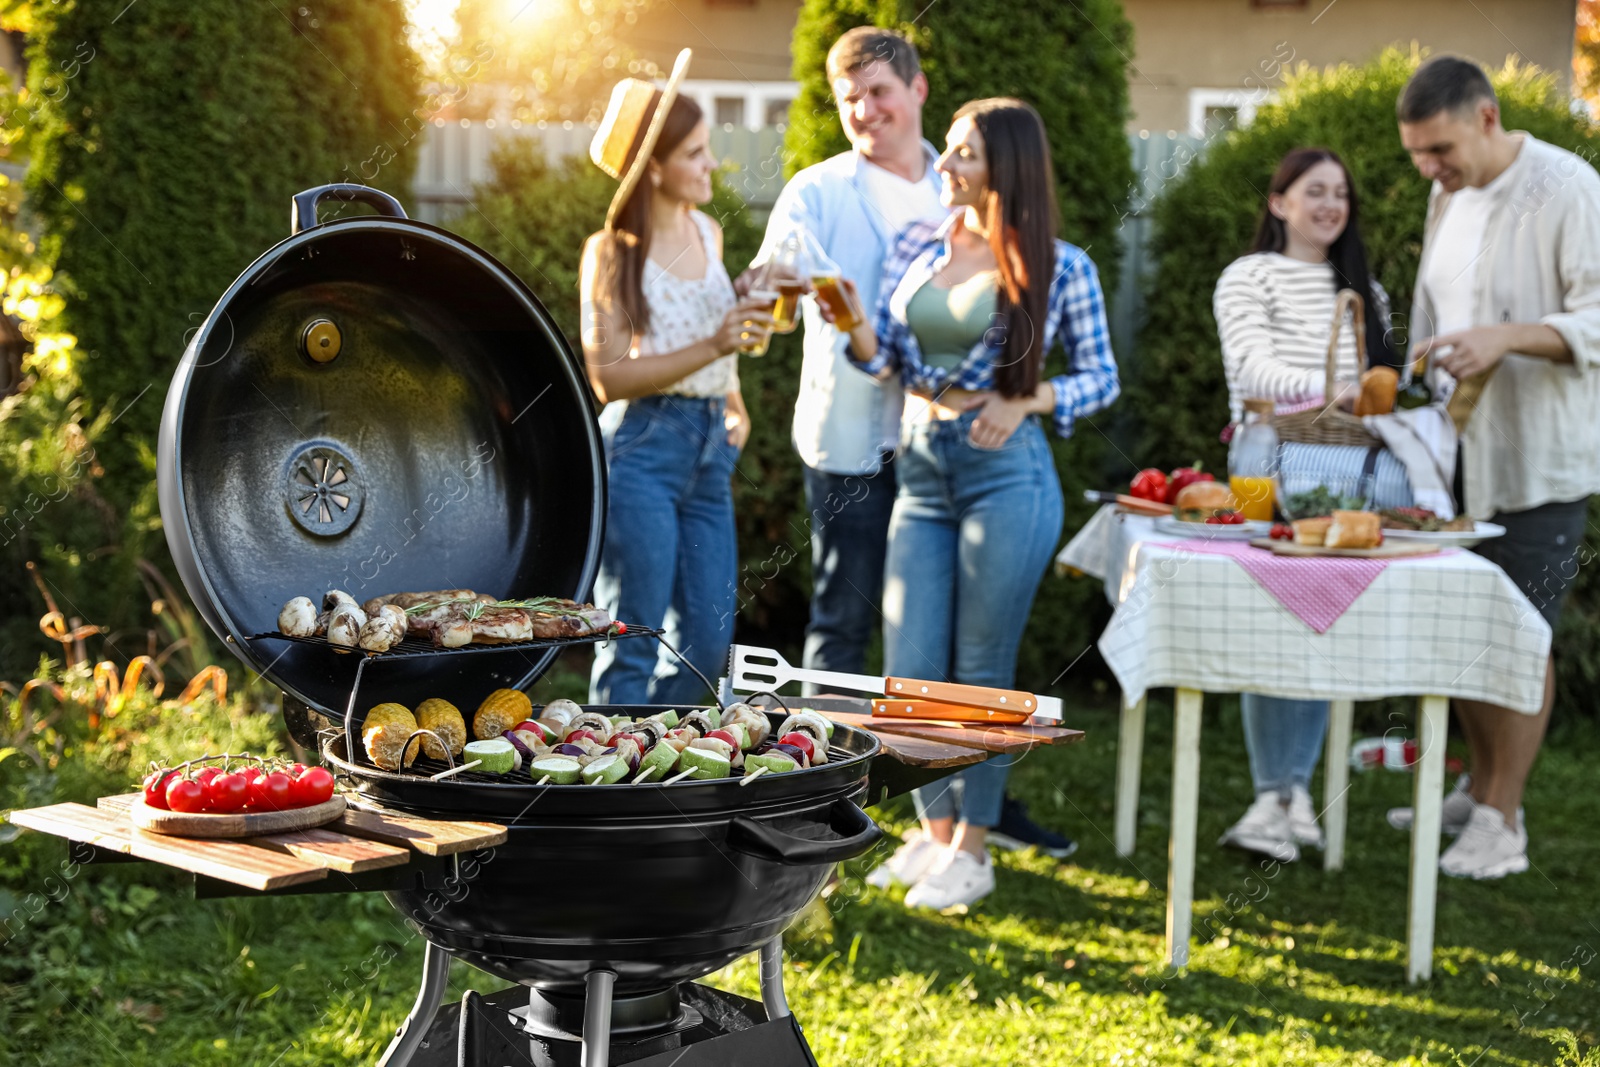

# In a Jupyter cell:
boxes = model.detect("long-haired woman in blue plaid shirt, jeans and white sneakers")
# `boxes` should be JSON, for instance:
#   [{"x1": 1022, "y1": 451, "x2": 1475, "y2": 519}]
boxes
[{"x1": 846, "y1": 99, "x2": 1118, "y2": 909}]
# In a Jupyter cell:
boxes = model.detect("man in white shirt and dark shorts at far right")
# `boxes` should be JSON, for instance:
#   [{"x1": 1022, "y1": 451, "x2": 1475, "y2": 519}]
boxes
[{"x1": 1390, "y1": 56, "x2": 1600, "y2": 878}]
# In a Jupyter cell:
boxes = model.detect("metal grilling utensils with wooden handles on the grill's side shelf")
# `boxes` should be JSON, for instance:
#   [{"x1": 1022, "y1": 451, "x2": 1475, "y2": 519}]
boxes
[{"x1": 728, "y1": 645, "x2": 1061, "y2": 725}]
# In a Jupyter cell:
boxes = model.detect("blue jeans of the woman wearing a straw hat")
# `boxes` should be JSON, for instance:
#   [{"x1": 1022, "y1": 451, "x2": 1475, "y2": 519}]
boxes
[{"x1": 592, "y1": 397, "x2": 739, "y2": 704}]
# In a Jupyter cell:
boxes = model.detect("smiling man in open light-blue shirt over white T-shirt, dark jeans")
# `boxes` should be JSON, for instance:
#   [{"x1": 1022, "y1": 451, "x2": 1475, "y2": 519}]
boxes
[{"x1": 757, "y1": 26, "x2": 949, "y2": 684}]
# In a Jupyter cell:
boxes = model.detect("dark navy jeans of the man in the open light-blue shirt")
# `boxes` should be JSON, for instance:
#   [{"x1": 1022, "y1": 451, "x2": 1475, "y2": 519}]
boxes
[{"x1": 800, "y1": 458, "x2": 894, "y2": 696}]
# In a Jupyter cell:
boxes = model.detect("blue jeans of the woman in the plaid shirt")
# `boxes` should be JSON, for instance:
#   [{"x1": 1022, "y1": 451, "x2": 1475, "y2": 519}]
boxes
[{"x1": 883, "y1": 413, "x2": 1061, "y2": 827}]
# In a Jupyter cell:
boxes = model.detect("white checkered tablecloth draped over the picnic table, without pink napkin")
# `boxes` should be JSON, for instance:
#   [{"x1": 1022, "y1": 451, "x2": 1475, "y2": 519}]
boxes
[{"x1": 1056, "y1": 506, "x2": 1550, "y2": 713}]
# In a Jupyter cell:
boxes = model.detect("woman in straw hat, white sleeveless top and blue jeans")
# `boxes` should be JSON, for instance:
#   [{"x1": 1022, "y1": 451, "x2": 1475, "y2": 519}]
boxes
[{"x1": 579, "y1": 48, "x2": 773, "y2": 704}]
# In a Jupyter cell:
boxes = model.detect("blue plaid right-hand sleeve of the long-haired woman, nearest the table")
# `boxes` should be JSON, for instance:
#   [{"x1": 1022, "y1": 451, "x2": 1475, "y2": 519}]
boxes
[{"x1": 1050, "y1": 242, "x2": 1122, "y2": 437}]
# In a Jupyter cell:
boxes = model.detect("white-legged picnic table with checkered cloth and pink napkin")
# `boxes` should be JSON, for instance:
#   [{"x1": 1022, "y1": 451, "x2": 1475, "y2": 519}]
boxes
[{"x1": 1056, "y1": 506, "x2": 1550, "y2": 982}]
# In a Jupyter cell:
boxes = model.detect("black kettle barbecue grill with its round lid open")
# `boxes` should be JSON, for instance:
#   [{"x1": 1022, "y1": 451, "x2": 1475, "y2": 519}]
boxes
[{"x1": 158, "y1": 186, "x2": 915, "y2": 1067}]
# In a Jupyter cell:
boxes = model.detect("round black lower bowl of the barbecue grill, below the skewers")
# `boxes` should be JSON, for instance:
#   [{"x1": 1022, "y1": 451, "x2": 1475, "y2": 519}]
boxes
[{"x1": 323, "y1": 707, "x2": 882, "y2": 997}]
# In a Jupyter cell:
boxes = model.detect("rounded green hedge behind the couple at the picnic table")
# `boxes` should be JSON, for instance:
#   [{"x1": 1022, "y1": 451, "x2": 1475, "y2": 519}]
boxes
[{"x1": 1120, "y1": 50, "x2": 1600, "y2": 709}]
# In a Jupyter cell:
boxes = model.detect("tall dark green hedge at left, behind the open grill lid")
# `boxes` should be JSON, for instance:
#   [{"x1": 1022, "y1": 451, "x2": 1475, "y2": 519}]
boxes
[{"x1": 0, "y1": 0, "x2": 422, "y2": 678}]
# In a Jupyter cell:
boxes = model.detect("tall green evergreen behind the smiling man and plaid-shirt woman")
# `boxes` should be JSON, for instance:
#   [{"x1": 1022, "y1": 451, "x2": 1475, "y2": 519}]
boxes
[{"x1": 784, "y1": 0, "x2": 1134, "y2": 688}]
